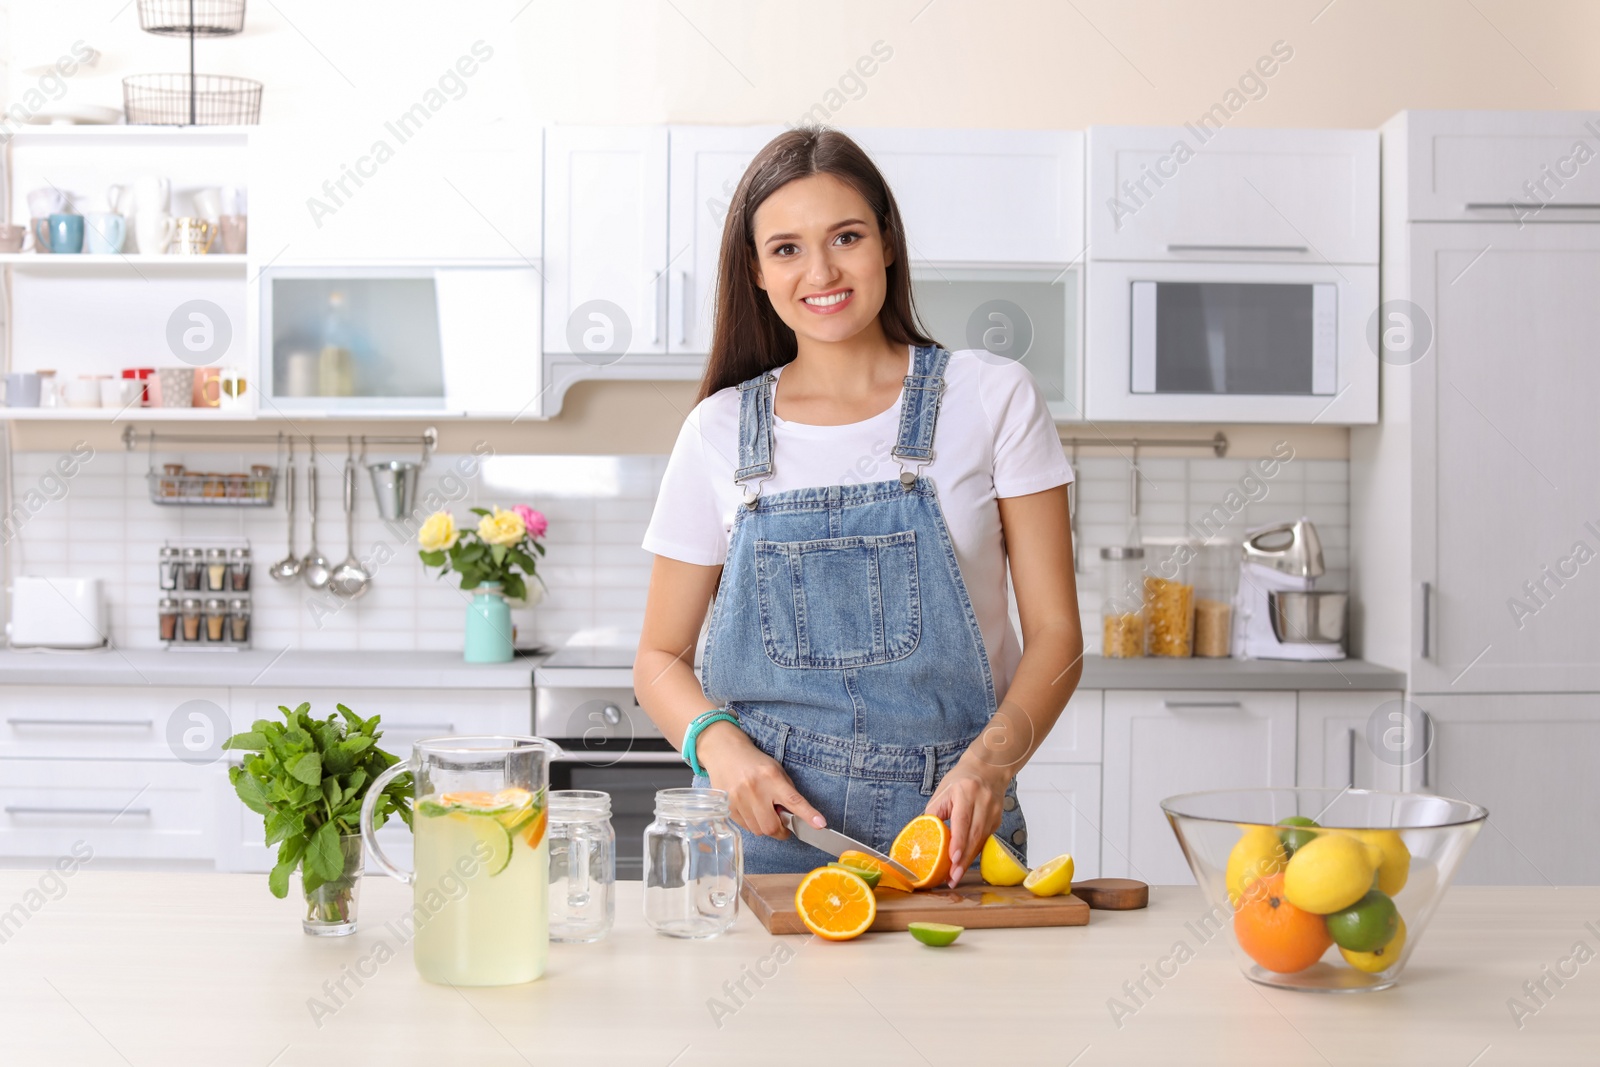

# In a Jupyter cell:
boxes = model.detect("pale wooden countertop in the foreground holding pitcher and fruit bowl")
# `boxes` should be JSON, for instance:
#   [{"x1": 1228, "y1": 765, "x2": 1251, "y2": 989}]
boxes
[{"x1": 0, "y1": 861, "x2": 1600, "y2": 1067}]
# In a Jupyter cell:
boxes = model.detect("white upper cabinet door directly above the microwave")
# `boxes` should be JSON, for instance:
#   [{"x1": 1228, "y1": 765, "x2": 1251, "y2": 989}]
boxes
[{"x1": 1088, "y1": 123, "x2": 1379, "y2": 264}]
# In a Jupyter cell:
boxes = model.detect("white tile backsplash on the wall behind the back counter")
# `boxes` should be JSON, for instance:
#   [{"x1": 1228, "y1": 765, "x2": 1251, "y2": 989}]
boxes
[{"x1": 8, "y1": 450, "x2": 1350, "y2": 651}]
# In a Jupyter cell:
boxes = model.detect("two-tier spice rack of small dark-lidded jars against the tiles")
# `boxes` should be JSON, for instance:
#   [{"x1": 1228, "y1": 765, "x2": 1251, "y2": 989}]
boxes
[{"x1": 157, "y1": 541, "x2": 254, "y2": 651}]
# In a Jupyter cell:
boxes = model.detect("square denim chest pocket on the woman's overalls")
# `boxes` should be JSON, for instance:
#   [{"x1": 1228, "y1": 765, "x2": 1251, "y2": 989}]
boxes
[{"x1": 755, "y1": 530, "x2": 922, "y2": 670}]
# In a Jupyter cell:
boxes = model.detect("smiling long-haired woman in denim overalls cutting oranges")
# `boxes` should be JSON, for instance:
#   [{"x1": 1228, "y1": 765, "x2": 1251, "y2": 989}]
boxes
[{"x1": 634, "y1": 130, "x2": 1083, "y2": 885}]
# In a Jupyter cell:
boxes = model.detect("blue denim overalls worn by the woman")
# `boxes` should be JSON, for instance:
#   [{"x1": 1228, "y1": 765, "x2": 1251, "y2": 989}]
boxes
[{"x1": 698, "y1": 347, "x2": 1027, "y2": 873}]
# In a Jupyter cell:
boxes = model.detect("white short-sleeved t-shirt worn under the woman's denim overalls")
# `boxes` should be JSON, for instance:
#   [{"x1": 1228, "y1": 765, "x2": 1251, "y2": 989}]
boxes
[{"x1": 645, "y1": 350, "x2": 1072, "y2": 699}]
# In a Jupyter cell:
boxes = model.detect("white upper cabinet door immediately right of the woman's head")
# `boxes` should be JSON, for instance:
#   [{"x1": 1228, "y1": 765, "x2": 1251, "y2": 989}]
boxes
[{"x1": 845, "y1": 128, "x2": 1083, "y2": 267}]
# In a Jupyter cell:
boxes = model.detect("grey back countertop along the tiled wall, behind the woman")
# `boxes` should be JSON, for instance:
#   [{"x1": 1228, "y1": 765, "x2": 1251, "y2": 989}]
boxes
[{"x1": 0, "y1": 649, "x2": 1405, "y2": 689}]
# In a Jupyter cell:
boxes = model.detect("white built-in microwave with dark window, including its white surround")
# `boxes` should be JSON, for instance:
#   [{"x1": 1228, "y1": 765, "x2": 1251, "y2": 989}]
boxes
[{"x1": 1085, "y1": 262, "x2": 1378, "y2": 424}]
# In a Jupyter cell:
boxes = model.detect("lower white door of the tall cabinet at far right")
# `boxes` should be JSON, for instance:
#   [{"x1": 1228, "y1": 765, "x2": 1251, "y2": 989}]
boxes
[{"x1": 1408, "y1": 693, "x2": 1600, "y2": 885}]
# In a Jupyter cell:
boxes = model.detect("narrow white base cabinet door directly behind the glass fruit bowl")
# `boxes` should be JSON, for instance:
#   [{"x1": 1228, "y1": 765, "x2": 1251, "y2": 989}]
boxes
[{"x1": 1296, "y1": 689, "x2": 1403, "y2": 790}]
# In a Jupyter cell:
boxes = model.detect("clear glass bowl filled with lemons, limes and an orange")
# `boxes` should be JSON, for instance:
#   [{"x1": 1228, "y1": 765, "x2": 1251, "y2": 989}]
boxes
[{"x1": 1162, "y1": 789, "x2": 1488, "y2": 993}]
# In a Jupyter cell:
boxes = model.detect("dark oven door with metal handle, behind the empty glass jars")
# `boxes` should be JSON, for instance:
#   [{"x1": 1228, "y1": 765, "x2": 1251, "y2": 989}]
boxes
[{"x1": 550, "y1": 748, "x2": 694, "y2": 878}]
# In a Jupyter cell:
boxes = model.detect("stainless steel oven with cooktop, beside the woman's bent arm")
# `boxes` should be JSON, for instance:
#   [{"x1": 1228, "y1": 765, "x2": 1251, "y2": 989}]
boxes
[{"x1": 533, "y1": 645, "x2": 693, "y2": 878}]
